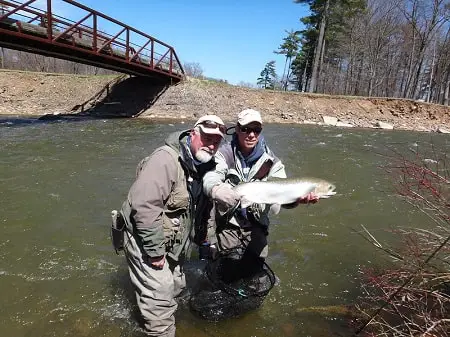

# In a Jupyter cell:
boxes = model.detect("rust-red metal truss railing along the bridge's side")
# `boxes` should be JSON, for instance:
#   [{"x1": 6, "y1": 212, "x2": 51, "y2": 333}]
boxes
[{"x1": 0, "y1": 0, "x2": 184, "y2": 79}]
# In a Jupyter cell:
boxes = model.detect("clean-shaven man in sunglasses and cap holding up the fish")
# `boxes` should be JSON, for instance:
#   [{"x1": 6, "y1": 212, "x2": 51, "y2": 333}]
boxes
[{"x1": 203, "y1": 109, "x2": 317, "y2": 281}]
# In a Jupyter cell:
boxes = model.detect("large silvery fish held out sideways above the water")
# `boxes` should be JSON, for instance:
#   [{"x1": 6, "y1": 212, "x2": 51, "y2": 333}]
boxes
[{"x1": 233, "y1": 178, "x2": 336, "y2": 207}]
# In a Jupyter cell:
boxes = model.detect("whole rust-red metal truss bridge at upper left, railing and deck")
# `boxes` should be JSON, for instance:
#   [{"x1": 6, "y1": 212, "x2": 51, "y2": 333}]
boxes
[{"x1": 0, "y1": 0, "x2": 184, "y2": 83}]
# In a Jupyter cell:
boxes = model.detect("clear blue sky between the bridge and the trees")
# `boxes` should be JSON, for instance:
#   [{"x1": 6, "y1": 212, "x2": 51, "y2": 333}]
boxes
[{"x1": 36, "y1": 0, "x2": 309, "y2": 84}]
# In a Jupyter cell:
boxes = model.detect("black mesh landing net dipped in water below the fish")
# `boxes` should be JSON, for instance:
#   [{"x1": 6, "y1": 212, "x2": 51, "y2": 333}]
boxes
[{"x1": 190, "y1": 248, "x2": 276, "y2": 321}]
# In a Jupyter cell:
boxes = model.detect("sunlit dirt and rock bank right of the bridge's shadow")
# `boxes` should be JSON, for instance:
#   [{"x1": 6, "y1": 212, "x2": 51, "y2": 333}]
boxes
[{"x1": 143, "y1": 79, "x2": 450, "y2": 133}]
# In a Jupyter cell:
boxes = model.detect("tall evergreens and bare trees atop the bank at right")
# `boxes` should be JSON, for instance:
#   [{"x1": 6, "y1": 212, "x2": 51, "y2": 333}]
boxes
[{"x1": 257, "y1": 0, "x2": 450, "y2": 105}]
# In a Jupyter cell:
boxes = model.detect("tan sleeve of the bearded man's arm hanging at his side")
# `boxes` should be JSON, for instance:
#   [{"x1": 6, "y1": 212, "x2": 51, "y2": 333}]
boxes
[{"x1": 129, "y1": 150, "x2": 178, "y2": 257}]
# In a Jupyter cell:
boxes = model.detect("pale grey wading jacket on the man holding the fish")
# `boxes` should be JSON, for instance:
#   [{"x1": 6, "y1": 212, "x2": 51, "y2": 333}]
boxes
[{"x1": 203, "y1": 136, "x2": 286, "y2": 227}]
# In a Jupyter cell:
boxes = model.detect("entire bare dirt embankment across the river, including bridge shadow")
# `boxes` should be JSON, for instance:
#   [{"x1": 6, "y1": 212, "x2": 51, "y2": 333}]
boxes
[{"x1": 0, "y1": 71, "x2": 450, "y2": 131}]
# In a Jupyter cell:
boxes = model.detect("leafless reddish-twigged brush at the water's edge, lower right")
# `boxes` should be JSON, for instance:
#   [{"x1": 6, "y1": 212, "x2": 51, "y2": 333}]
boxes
[{"x1": 356, "y1": 147, "x2": 450, "y2": 337}]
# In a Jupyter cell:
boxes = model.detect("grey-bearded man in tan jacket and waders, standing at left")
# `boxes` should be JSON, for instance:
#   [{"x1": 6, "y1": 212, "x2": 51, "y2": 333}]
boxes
[{"x1": 120, "y1": 115, "x2": 226, "y2": 337}]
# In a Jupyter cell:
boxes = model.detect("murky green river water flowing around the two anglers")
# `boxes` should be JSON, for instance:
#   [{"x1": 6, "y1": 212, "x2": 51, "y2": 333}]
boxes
[{"x1": 0, "y1": 118, "x2": 450, "y2": 337}]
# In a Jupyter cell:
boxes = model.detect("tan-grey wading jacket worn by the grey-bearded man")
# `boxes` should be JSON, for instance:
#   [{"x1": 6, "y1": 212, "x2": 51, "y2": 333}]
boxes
[{"x1": 121, "y1": 130, "x2": 215, "y2": 260}]
